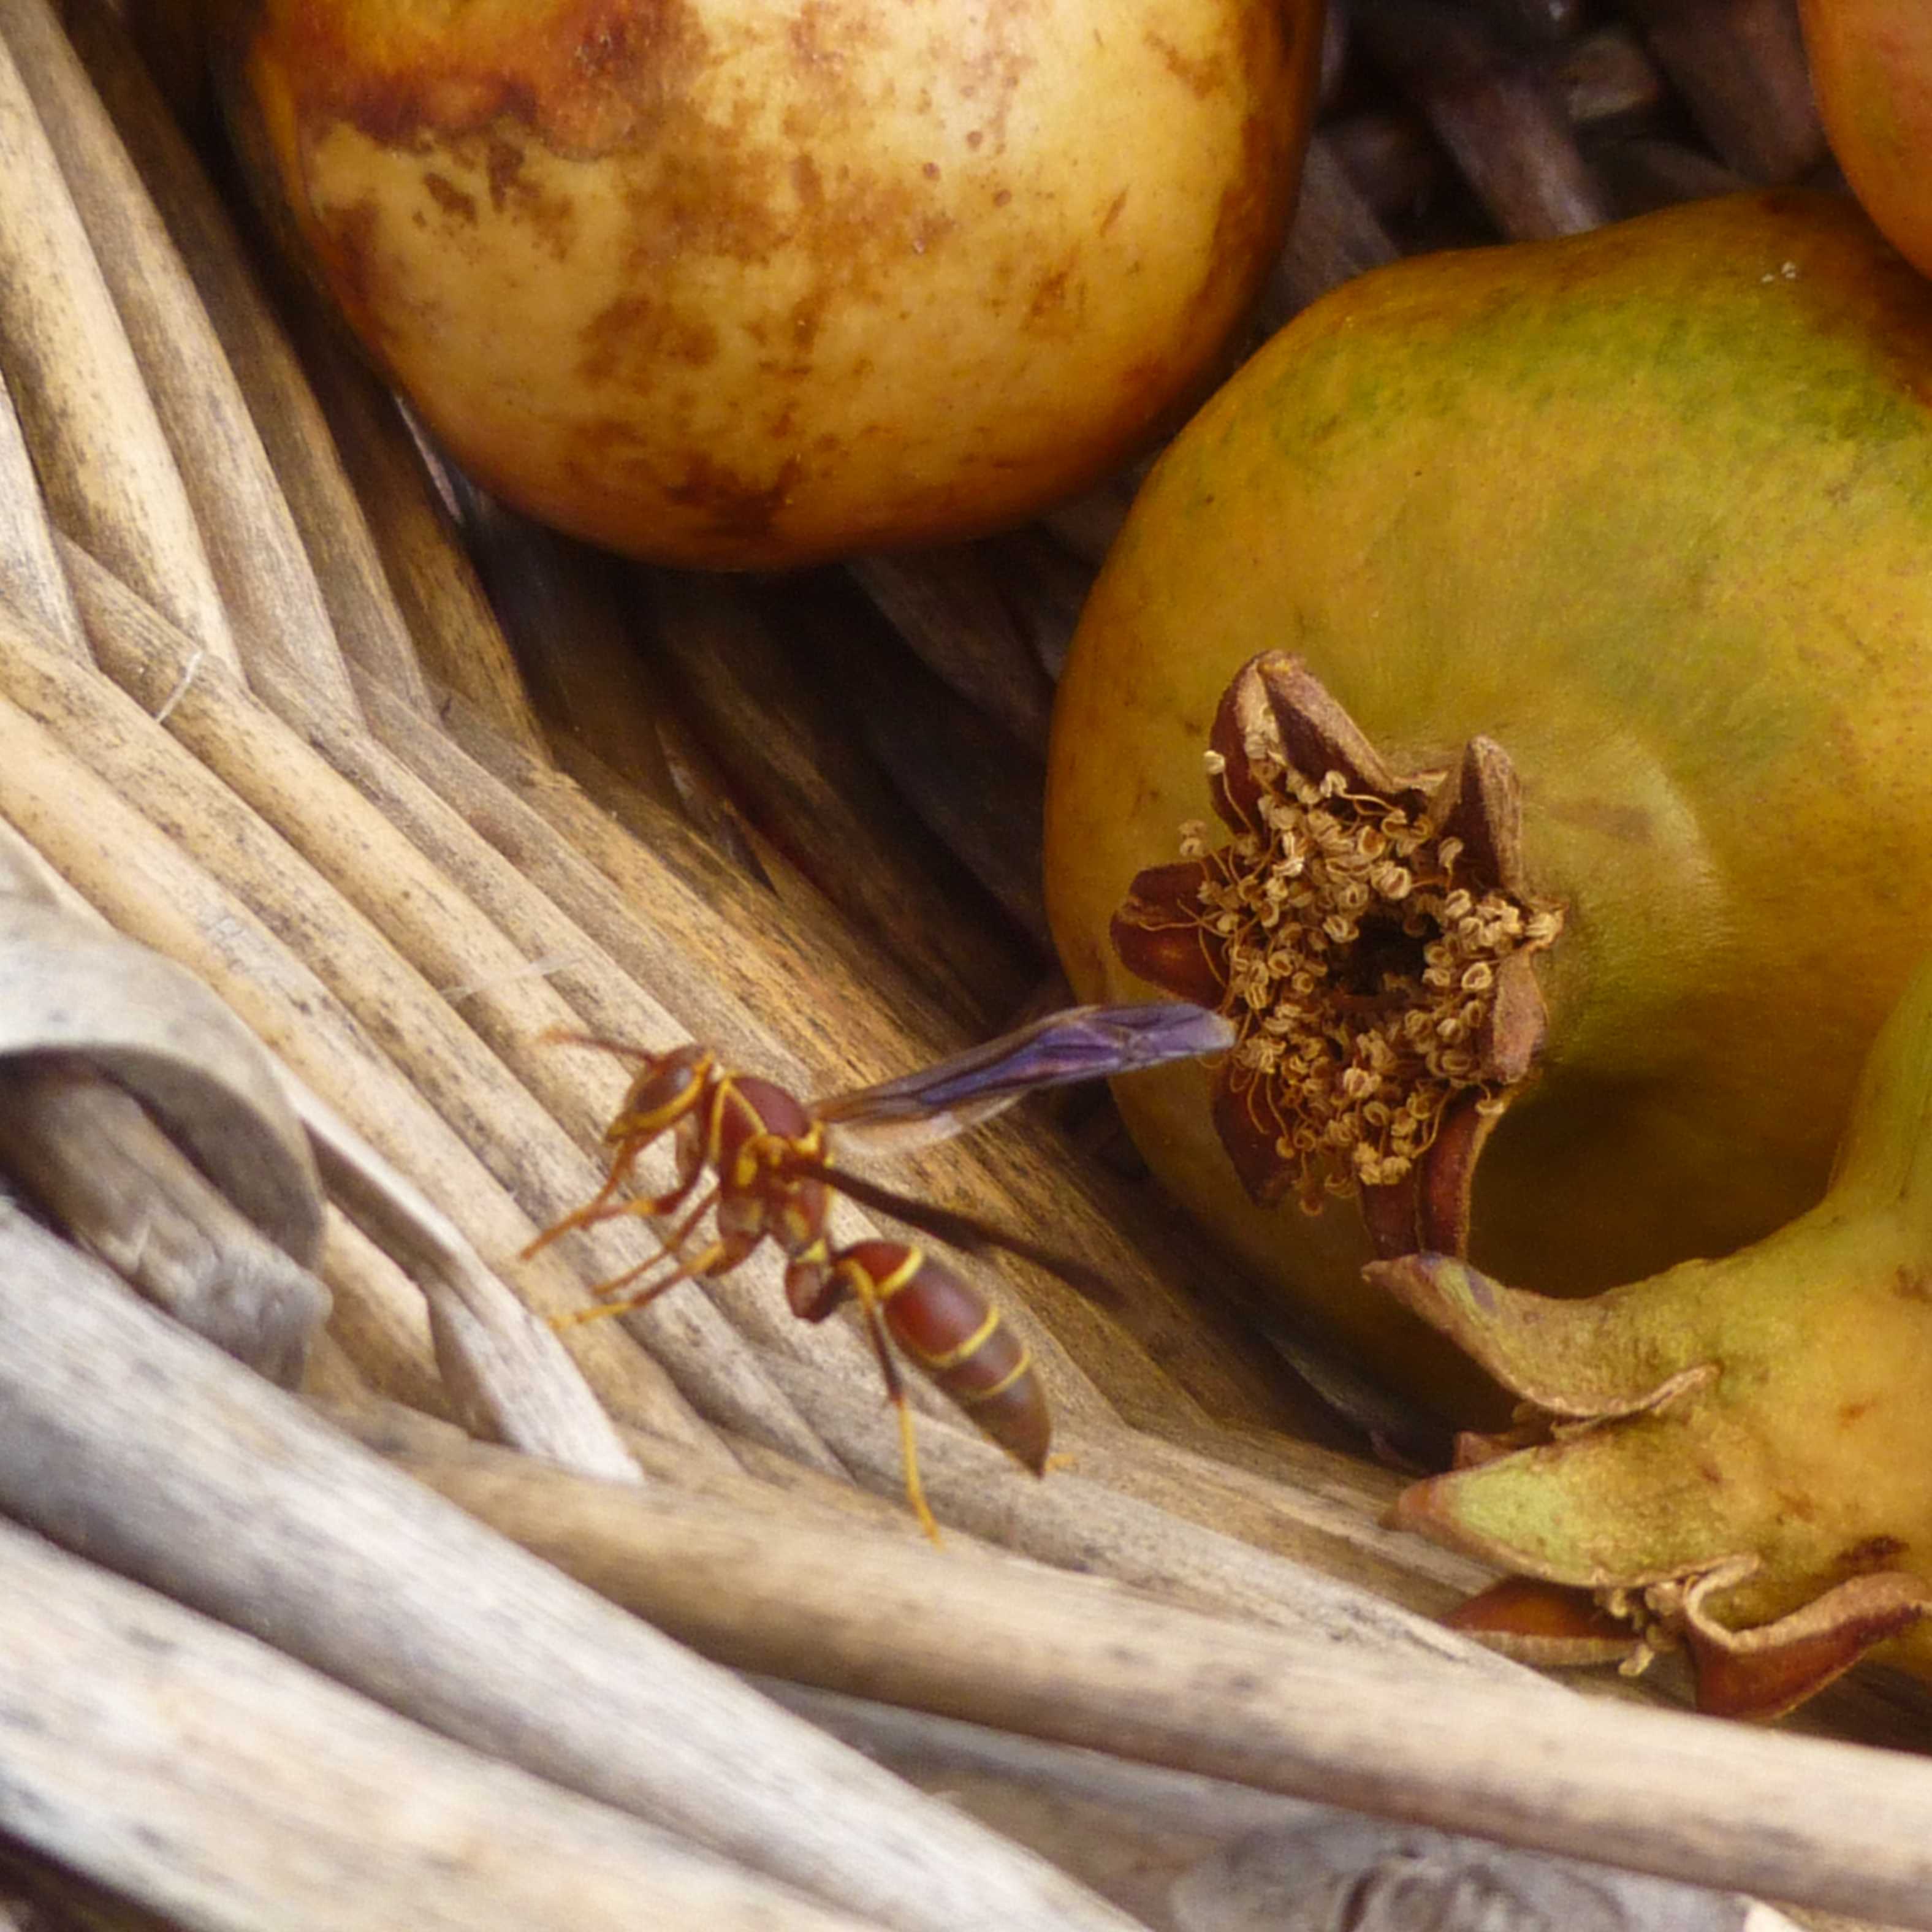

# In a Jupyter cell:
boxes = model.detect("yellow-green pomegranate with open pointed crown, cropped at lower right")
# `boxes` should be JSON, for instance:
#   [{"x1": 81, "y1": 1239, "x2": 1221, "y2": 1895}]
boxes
[{"x1": 1368, "y1": 943, "x2": 1932, "y2": 1716}]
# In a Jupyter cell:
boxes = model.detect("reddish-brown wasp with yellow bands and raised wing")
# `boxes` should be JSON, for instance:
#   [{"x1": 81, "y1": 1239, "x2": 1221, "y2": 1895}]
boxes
[{"x1": 523, "y1": 1001, "x2": 1234, "y2": 1540}]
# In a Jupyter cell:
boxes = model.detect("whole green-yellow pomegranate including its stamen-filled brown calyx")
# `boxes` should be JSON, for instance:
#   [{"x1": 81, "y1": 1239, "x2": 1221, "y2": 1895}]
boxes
[{"x1": 1047, "y1": 193, "x2": 1932, "y2": 1420}]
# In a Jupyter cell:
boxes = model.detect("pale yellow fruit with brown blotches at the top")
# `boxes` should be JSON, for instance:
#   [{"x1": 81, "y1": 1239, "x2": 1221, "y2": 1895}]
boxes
[{"x1": 213, "y1": 0, "x2": 1320, "y2": 566}]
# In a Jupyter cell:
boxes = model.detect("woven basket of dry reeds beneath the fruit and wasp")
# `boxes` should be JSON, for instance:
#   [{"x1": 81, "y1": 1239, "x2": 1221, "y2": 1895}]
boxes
[{"x1": 0, "y1": 0, "x2": 1901, "y2": 1932}]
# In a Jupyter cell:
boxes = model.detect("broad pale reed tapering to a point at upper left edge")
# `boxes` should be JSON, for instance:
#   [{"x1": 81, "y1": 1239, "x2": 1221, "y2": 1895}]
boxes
[{"x1": 0, "y1": 13, "x2": 236, "y2": 663}]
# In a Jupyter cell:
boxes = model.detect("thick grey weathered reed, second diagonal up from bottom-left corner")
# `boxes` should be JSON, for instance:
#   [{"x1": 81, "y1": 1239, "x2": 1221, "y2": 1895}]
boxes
[{"x1": 0, "y1": 1215, "x2": 1127, "y2": 1932}]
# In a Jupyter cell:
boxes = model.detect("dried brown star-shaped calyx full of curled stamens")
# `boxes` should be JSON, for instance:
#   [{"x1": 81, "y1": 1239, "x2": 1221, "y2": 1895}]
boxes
[{"x1": 1113, "y1": 651, "x2": 1563, "y2": 1254}]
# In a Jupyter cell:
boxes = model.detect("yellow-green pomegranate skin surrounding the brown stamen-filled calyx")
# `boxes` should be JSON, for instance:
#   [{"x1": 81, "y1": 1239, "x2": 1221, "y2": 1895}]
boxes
[{"x1": 1047, "y1": 193, "x2": 1932, "y2": 1407}]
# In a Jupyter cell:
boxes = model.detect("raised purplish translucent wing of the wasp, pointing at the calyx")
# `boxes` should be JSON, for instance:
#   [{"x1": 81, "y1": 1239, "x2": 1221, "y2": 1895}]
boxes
[{"x1": 813, "y1": 999, "x2": 1234, "y2": 1146}]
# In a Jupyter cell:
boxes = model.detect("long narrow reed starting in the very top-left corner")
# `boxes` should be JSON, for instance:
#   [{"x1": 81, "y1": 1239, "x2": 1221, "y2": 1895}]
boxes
[{"x1": 0, "y1": 0, "x2": 356, "y2": 713}]
